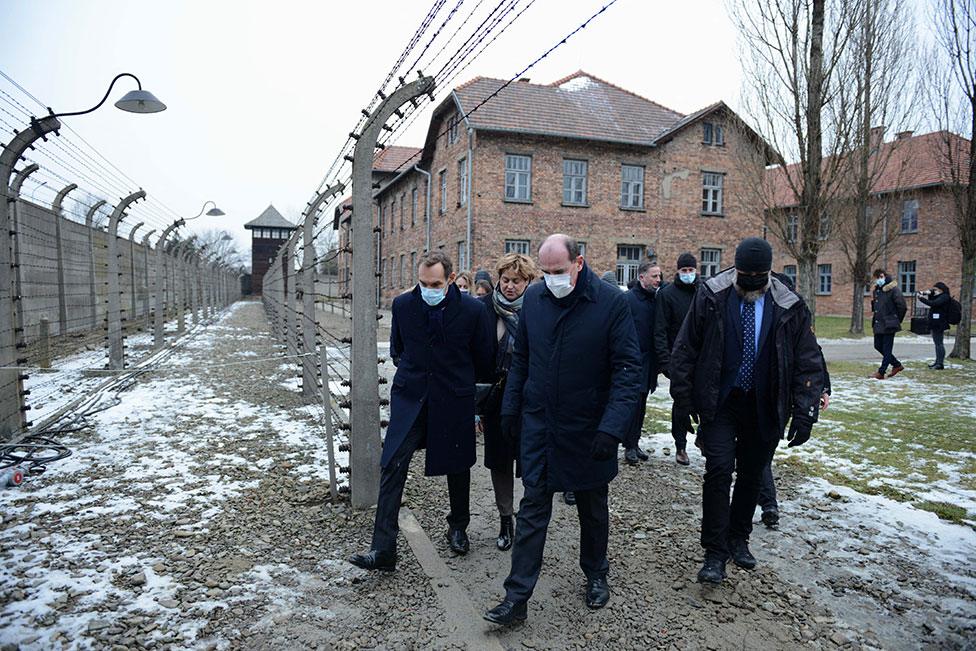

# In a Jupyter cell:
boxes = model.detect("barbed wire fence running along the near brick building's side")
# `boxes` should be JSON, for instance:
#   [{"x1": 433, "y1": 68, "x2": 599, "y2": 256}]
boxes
[{"x1": 263, "y1": 0, "x2": 617, "y2": 508}]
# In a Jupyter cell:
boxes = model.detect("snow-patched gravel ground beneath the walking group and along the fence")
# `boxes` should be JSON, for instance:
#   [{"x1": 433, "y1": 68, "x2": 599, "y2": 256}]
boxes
[{"x1": 0, "y1": 302, "x2": 976, "y2": 649}]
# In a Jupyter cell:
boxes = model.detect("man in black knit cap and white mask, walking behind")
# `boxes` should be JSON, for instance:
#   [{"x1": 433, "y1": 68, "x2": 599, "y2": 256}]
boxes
[{"x1": 654, "y1": 252, "x2": 701, "y2": 466}]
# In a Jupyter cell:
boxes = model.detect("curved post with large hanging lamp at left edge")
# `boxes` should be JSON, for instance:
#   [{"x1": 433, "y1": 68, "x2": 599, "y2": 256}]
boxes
[{"x1": 0, "y1": 73, "x2": 166, "y2": 438}]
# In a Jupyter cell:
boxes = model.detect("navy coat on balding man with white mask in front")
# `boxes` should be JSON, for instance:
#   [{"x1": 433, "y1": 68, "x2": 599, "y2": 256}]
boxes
[{"x1": 502, "y1": 264, "x2": 641, "y2": 491}]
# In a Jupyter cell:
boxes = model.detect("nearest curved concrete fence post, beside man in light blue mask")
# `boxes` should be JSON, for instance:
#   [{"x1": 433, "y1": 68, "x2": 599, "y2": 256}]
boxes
[{"x1": 349, "y1": 77, "x2": 434, "y2": 509}]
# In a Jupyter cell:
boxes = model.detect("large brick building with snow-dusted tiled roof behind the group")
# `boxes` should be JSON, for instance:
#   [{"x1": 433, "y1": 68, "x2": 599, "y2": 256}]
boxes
[{"x1": 336, "y1": 71, "x2": 763, "y2": 303}]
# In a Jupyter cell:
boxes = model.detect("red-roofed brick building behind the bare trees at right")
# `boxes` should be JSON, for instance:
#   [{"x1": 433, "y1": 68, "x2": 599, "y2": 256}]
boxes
[{"x1": 769, "y1": 128, "x2": 976, "y2": 321}]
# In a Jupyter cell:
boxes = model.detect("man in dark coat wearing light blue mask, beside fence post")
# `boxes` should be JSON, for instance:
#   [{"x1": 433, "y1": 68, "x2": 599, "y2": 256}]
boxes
[{"x1": 349, "y1": 251, "x2": 495, "y2": 571}]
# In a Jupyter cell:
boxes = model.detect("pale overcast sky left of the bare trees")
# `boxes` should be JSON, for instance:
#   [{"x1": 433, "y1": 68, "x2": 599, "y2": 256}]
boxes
[{"x1": 0, "y1": 0, "x2": 741, "y2": 255}]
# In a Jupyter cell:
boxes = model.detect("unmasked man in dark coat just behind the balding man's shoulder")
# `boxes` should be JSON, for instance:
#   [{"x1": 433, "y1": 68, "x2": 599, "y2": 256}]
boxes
[{"x1": 624, "y1": 260, "x2": 661, "y2": 465}]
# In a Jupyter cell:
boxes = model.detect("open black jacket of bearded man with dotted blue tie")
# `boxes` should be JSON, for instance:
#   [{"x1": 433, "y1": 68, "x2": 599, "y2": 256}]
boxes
[{"x1": 671, "y1": 269, "x2": 828, "y2": 437}]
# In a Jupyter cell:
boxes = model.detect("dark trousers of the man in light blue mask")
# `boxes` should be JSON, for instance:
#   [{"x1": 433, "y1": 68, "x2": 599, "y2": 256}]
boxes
[{"x1": 371, "y1": 407, "x2": 471, "y2": 553}]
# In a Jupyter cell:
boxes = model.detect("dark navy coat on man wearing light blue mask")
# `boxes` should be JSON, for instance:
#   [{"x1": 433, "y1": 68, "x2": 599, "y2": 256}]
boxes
[{"x1": 380, "y1": 285, "x2": 495, "y2": 476}]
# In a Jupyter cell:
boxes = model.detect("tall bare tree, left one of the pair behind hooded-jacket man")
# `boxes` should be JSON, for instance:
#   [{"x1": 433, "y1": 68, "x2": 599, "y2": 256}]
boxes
[{"x1": 731, "y1": 0, "x2": 862, "y2": 312}]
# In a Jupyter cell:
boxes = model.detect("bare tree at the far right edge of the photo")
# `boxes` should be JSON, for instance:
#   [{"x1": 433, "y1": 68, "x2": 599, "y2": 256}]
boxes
[{"x1": 929, "y1": 0, "x2": 976, "y2": 359}]
